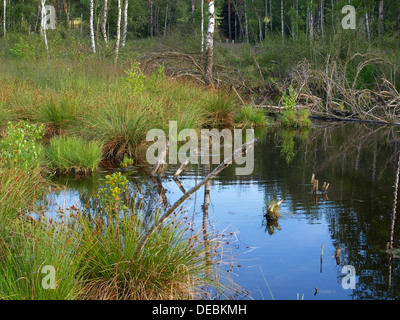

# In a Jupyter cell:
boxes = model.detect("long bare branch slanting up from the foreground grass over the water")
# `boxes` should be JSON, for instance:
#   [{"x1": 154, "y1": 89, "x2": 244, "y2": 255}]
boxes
[{"x1": 137, "y1": 138, "x2": 258, "y2": 253}]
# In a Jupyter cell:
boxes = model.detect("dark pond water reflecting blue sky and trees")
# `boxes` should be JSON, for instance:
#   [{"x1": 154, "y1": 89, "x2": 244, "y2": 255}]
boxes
[{"x1": 45, "y1": 123, "x2": 400, "y2": 300}]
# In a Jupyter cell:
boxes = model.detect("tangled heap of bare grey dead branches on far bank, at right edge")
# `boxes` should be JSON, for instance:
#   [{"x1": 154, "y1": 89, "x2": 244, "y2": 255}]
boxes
[{"x1": 289, "y1": 54, "x2": 400, "y2": 124}]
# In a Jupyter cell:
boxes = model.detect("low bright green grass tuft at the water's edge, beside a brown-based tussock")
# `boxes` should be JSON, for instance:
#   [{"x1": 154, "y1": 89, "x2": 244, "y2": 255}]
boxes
[{"x1": 46, "y1": 136, "x2": 103, "y2": 173}]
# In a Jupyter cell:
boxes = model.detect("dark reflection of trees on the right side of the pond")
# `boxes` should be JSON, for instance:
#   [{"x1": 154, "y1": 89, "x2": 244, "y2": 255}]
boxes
[{"x1": 278, "y1": 123, "x2": 400, "y2": 299}]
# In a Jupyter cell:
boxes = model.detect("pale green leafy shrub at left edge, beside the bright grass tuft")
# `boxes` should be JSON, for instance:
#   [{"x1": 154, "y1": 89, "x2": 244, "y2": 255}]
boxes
[{"x1": 0, "y1": 121, "x2": 44, "y2": 169}]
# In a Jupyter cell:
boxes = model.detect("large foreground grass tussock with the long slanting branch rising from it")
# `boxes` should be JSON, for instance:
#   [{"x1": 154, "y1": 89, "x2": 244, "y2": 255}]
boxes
[{"x1": 79, "y1": 204, "x2": 223, "y2": 300}]
